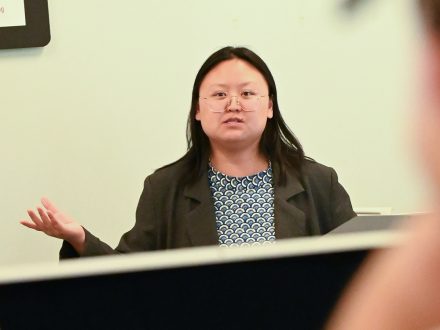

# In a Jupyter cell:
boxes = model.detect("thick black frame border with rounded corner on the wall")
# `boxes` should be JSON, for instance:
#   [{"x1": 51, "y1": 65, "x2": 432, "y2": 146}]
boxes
[{"x1": 0, "y1": 0, "x2": 50, "y2": 49}]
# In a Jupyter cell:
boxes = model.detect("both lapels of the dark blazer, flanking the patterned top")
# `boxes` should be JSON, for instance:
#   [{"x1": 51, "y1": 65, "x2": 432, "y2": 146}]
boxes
[{"x1": 184, "y1": 162, "x2": 307, "y2": 246}]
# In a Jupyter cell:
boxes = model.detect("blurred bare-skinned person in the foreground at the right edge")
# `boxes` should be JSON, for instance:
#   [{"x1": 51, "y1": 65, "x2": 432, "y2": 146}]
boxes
[{"x1": 327, "y1": 0, "x2": 440, "y2": 330}]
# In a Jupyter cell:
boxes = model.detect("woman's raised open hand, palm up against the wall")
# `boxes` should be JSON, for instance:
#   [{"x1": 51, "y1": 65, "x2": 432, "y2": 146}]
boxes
[{"x1": 20, "y1": 198, "x2": 85, "y2": 252}]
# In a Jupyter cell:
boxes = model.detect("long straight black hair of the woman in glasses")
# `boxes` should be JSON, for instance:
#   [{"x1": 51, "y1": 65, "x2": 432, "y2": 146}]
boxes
[{"x1": 161, "y1": 47, "x2": 305, "y2": 185}]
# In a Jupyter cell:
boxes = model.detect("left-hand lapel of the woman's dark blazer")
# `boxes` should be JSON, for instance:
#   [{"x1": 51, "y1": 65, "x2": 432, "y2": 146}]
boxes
[{"x1": 184, "y1": 172, "x2": 218, "y2": 246}]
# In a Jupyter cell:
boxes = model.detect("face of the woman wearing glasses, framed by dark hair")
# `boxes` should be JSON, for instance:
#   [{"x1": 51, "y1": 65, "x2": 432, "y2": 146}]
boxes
[{"x1": 196, "y1": 59, "x2": 273, "y2": 149}]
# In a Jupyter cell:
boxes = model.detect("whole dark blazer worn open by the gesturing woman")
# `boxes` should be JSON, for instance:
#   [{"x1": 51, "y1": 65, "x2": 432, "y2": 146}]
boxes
[{"x1": 60, "y1": 161, "x2": 356, "y2": 258}]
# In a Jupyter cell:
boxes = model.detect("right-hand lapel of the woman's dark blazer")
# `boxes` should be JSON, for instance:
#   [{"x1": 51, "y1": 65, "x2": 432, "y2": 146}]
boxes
[{"x1": 273, "y1": 164, "x2": 307, "y2": 239}]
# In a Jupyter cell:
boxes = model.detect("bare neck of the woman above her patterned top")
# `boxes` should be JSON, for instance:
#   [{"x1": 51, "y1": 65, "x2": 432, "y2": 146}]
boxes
[{"x1": 211, "y1": 144, "x2": 269, "y2": 177}]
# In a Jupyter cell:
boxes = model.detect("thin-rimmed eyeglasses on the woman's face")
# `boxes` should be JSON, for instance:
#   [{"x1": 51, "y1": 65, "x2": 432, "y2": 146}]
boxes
[{"x1": 200, "y1": 91, "x2": 268, "y2": 112}]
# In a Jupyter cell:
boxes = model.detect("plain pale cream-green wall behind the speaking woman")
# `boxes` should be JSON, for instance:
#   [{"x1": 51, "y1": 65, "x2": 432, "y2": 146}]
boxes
[{"x1": 0, "y1": 0, "x2": 422, "y2": 265}]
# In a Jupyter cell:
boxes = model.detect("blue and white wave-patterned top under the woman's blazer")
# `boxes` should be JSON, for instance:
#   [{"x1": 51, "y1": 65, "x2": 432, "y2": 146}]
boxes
[{"x1": 208, "y1": 164, "x2": 275, "y2": 246}]
